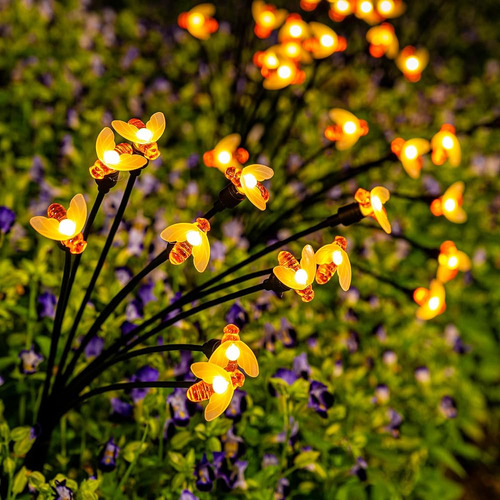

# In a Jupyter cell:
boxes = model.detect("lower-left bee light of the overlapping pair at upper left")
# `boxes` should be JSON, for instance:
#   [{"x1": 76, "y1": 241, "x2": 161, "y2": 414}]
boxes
[{"x1": 89, "y1": 127, "x2": 148, "y2": 179}]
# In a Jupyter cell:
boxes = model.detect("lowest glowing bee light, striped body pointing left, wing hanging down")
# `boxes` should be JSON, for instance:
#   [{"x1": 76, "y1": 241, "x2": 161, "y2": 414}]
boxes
[{"x1": 186, "y1": 362, "x2": 235, "y2": 421}]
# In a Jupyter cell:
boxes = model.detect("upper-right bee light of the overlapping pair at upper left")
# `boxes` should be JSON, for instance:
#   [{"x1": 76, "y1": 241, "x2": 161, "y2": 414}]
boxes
[{"x1": 111, "y1": 112, "x2": 165, "y2": 160}]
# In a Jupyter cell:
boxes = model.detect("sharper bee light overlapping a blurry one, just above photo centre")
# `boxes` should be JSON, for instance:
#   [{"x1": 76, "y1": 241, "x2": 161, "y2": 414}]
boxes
[{"x1": 225, "y1": 164, "x2": 274, "y2": 210}]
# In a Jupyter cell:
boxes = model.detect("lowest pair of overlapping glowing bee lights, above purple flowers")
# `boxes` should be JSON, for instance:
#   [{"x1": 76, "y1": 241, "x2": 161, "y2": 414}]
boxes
[{"x1": 187, "y1": 324, "x2": 259, "y2": 421}]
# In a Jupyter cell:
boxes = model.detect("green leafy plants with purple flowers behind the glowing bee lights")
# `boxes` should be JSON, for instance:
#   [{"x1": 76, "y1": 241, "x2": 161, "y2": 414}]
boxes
[{"x1": 0, "y1": 0, "x2": 500, "y2": 500}]
